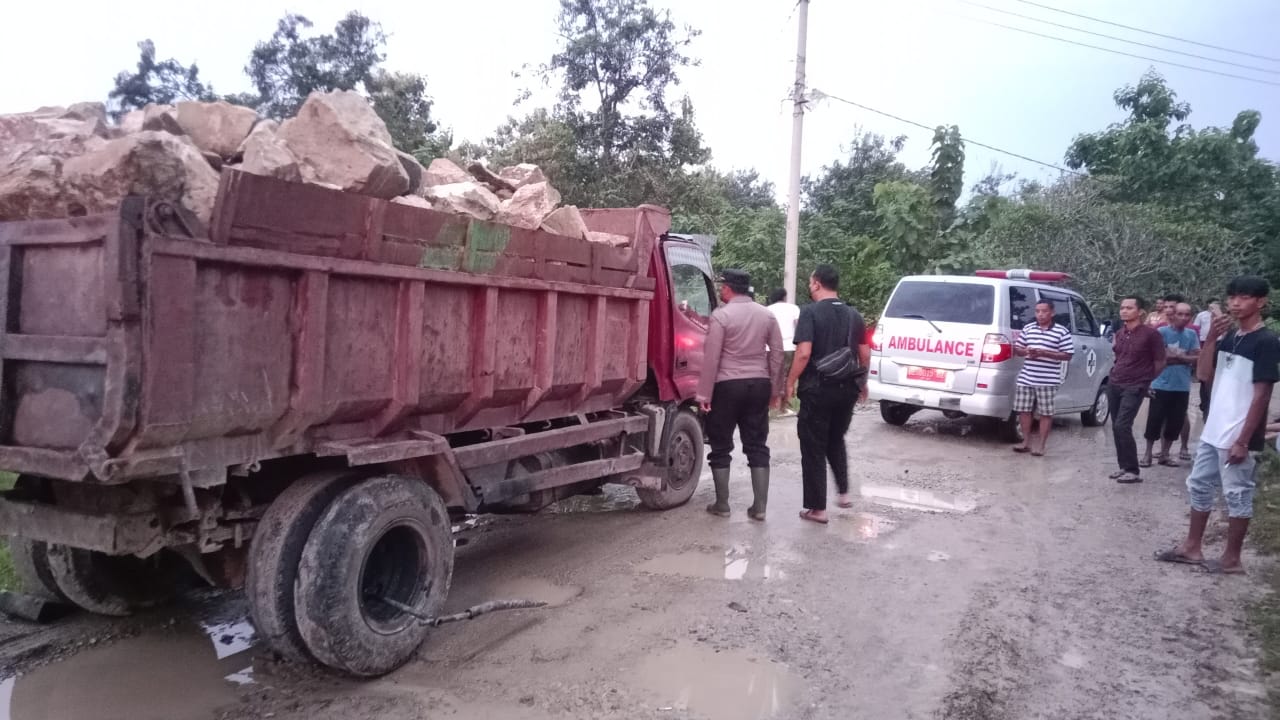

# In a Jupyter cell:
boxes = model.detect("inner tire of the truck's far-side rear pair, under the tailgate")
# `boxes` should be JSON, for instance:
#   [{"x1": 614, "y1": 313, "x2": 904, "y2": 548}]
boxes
[{"x1": 47, "y1": 544, "x2": 177, "y2": 618}]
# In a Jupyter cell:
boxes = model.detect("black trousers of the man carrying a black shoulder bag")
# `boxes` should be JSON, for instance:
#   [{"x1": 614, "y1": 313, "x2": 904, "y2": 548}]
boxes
[{"x1": 796, "y1": 380, "x2": 859, "y2": 510}]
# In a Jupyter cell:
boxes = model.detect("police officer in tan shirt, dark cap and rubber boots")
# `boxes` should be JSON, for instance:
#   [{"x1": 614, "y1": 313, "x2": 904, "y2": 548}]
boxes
[{"x1": 698, "y1": 270, "x2": 785, "y2": 520}]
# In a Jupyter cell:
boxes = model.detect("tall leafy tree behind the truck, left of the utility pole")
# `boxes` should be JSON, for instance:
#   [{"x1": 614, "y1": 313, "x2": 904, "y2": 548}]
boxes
[{"x1": 488, "y1": 0, "x2": 710, "y2": 210}]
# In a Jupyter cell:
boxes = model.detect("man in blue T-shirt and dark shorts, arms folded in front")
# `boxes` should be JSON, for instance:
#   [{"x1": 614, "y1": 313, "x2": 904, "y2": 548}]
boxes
[{"x1": 1138, "y1": 302, "x2": 1199, "y2": 468}]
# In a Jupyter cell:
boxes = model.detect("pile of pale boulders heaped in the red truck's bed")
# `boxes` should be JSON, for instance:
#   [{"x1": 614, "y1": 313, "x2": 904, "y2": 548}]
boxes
[{"x1": 0, "y1": 91, "x2": 628, "y2": 245}]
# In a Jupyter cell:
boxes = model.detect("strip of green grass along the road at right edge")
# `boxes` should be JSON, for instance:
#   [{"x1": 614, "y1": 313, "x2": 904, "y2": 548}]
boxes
[{"x1": 1249, "y1": 450, "x2": 1280, "y2": 717}]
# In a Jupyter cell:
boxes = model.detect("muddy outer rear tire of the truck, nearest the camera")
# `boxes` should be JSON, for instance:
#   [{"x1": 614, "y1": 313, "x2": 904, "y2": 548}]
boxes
[{"x1": 294, "y1": 475, "x2": 453, "y2": 678}]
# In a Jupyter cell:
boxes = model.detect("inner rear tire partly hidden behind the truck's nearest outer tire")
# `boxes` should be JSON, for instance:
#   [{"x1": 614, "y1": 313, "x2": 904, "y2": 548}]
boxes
[{"x1": 244, "y1": 470, "x2": 360, "y2": 662}]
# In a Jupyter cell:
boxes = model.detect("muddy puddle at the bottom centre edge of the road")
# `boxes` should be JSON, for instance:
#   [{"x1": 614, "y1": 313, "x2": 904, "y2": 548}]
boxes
[{"x1": 634, "y1": 643, "x2": 801, "y2": 720}]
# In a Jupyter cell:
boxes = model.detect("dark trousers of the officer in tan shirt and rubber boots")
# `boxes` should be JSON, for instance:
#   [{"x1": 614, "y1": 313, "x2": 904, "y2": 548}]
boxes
[{"x1": 707, "y1": 378, "x2": 773, "y2": 470}]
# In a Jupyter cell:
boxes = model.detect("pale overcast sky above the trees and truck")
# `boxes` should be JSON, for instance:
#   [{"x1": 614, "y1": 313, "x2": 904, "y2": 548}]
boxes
[{"x1": 0, "y1": 0, "x2": 1280, "y2": 196}]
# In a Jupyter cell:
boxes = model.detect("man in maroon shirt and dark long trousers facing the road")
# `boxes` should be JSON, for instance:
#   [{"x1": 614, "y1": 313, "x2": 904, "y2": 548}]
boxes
[{"x1": 1107, "y1": 296, "x2": 1167, "y2": 483}]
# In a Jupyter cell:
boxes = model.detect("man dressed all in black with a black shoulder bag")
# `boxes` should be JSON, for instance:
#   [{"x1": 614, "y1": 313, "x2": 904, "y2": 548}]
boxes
[{"x1": 787, "y1": 265, "x2": 870, "y2": 524}]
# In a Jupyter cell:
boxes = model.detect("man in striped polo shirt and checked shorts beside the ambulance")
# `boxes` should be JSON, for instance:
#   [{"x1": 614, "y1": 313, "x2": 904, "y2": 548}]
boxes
[{"x1": 1014, "y1": 300, "x2": 1073, "y2": 456}]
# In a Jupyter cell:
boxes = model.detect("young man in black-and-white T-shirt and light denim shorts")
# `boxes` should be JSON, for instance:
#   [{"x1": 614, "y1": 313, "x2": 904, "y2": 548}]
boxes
[{"x1": 1156, "y1": 277, "x2": 1280, "y2": 575}]
